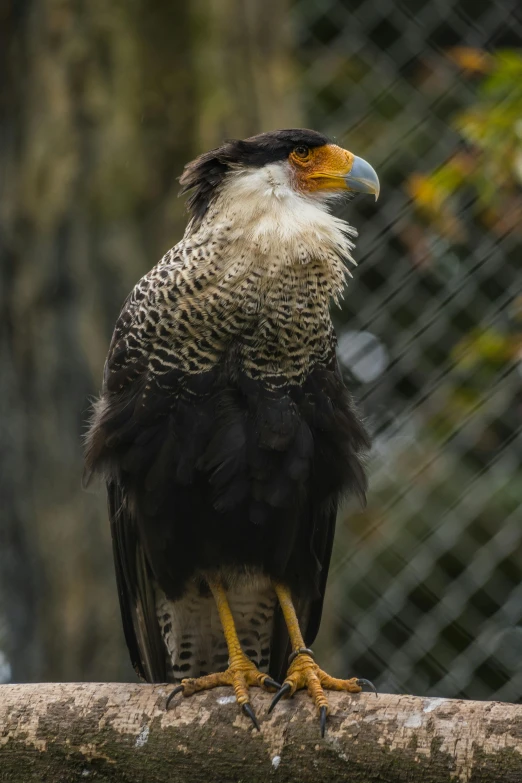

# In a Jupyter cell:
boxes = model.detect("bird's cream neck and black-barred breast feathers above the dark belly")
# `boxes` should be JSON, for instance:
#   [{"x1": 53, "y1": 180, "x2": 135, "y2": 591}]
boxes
[{"x1": 105, "y1": 162, "x2": 356, "y2": 382}]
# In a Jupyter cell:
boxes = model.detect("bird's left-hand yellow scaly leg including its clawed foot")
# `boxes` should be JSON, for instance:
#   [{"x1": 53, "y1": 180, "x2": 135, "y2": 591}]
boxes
[{"x1": 166, "y1": 579, "x2": 280, "y2": 731}]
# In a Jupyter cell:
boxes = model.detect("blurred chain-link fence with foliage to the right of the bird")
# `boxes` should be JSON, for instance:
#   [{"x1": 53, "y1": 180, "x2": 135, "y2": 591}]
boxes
[{"x1": 294, "y1": 0, "x2": 522, "y2": 701}]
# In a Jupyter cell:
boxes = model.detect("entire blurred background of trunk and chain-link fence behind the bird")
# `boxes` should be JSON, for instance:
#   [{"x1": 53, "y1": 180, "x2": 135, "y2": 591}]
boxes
[{"x1": 0, "y1": 0, "x2": 522, "y2": 701}]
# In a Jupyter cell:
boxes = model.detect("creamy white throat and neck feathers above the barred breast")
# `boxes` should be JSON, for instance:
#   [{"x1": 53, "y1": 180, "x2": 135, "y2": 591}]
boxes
[{"x1": 184, "y1": 161, "x2": 357, "y2": 302}]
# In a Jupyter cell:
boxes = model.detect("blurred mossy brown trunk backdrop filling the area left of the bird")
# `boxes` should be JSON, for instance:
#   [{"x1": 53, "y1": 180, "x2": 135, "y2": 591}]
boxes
[{"x1": 0, "y1": 0, "x2": 299, "y2": 680}]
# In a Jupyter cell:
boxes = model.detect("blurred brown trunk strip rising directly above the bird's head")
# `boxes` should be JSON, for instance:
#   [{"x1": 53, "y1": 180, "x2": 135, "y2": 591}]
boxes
[{"x1": 191, "y1": 0, "x2": 302, "y2": 149}]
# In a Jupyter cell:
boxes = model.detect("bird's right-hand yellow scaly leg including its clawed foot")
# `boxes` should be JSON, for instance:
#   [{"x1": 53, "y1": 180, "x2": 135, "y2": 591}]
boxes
[{"x1": 268, "y1": 583, "x2": 375, "y2": 737}]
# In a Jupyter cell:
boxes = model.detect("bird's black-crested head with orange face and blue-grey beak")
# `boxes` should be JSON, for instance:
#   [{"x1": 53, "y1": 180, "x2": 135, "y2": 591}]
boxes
[{"x1": 180, "y1": 129, "x2": 379, "y2": 221}]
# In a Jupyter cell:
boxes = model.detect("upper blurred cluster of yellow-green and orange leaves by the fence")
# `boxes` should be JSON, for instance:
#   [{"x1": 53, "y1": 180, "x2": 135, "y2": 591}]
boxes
[{"x1": 408, "y1": 49, "x2": 522, "y2": 242}]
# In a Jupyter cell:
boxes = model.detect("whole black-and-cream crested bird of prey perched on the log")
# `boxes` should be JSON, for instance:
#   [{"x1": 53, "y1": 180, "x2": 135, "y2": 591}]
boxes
[{"x1": 84, "y1": 129, "x2": 379, "y2": 736}]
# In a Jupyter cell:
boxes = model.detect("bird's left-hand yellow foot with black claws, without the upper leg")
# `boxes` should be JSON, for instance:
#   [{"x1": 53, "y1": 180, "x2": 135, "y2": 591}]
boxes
[{"x1": 166, "y1": 653, "x2": 281, "y2": 731}]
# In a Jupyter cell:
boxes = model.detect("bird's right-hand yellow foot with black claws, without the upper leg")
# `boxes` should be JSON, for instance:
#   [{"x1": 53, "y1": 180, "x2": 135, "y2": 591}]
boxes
[{"x1": 268, "y1": 647, "x2": 377, "y2": 737}]
